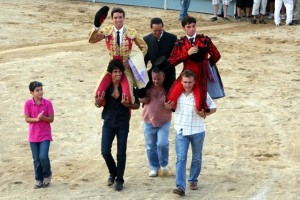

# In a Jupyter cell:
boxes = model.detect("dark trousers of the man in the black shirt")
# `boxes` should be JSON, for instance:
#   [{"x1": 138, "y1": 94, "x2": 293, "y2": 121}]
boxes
[{"x1": 101, "y1": 121, "x2": 129, "y2": 183}]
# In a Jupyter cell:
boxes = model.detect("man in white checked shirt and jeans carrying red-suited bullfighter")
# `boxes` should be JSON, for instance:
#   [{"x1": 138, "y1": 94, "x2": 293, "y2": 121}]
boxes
[{"x1": 165, "y1": 70, "x2": 217, "y2": 196}]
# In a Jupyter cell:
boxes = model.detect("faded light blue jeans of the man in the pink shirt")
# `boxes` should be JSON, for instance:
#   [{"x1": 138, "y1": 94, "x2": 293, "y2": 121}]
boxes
[{"x1": 144, "y1": 122, "x2": 171, "y2": 170}]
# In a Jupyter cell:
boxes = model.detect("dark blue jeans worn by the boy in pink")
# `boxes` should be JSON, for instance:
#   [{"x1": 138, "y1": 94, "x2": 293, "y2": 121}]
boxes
[{"x1": 30, "y1": 140, "x2": 52, "y2": 181}]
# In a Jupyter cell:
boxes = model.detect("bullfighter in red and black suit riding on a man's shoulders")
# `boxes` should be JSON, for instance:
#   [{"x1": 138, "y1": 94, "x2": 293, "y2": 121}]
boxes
[{"x1": 167, "y1": 16, "x2": 221, "y2": 111}]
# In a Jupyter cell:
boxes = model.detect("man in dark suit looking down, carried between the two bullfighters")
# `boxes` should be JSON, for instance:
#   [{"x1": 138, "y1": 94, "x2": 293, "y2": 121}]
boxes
[{"x1": 139, "y1": 17, "x2": 177, "y2": 97}]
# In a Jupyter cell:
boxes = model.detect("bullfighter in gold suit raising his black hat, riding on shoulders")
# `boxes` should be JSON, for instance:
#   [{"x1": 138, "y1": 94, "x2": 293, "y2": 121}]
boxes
[{"x1": 89, "y1": 6, "x2": 148, "y2": 105}]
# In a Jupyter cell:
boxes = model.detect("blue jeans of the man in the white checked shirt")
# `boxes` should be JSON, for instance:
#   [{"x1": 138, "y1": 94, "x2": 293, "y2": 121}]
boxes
[{"x1": 175, "y1": 132, "x2": 205, "y2": 191}]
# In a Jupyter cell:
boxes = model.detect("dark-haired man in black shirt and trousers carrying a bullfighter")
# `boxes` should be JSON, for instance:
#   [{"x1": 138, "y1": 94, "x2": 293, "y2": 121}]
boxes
[{"x1": 95, "y1": 60, "x2": 140, "y2": 191}]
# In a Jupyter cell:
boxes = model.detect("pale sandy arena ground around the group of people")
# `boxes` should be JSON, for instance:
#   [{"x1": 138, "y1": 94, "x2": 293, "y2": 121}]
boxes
[{"x1": 0, "y1": 0, "x2": 300, "y2": 200}]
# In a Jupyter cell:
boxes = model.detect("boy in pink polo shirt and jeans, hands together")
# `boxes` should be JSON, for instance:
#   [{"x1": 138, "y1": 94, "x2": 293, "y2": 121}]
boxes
[{"x1": 24, "y1": 81, "x2": 54, "y2": 188}]
